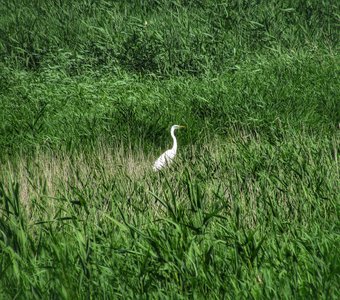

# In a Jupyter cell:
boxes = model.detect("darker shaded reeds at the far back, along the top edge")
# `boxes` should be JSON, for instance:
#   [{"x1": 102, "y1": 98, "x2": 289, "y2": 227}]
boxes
[{"x1": 0, "y1": 0, "x2": 339, "y2": 77}]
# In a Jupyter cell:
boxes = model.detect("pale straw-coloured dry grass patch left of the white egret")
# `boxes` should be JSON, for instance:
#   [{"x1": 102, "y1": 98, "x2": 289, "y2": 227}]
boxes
[{"x1": 0, "y1": 145, "x2": 152, "y2": 205}]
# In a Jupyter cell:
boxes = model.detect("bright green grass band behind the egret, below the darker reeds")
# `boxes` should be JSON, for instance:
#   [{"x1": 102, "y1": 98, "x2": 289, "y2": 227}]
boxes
[{"x1": 0, "y1": 54, "x2": 340, "y2": 153}]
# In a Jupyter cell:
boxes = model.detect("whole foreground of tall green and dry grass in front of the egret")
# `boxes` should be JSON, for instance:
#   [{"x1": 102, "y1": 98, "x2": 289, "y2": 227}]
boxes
[{"x1": 0, "y1": 135, "x2": 339, "y2": 298}]
